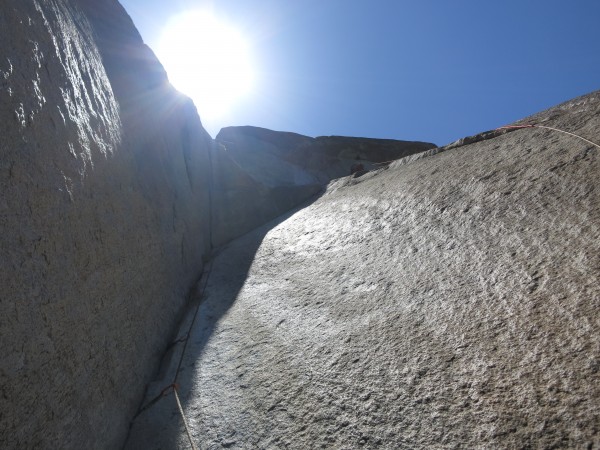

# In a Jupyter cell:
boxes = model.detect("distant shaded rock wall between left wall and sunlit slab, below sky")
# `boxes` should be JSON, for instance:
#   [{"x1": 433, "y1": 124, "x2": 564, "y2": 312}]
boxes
[{"x1": 213, "y1": 126, "x2": 435, "y2": 245}]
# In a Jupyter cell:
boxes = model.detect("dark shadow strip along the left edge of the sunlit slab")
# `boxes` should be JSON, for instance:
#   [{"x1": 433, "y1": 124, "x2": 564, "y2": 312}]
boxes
[{"x1": 124, "y1": 192, "x2": 323, "y2": 450}]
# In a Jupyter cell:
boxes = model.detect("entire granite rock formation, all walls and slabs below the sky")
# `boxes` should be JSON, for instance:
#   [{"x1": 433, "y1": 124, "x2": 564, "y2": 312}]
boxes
[{"x1": 0, "y1": 0, "x2": 600, "y2": 449}]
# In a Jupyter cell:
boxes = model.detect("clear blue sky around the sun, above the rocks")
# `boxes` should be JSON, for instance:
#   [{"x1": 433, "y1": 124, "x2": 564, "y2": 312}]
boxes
[{"x1": 120, "y1": 0, "x2": 600, "y2": 145}]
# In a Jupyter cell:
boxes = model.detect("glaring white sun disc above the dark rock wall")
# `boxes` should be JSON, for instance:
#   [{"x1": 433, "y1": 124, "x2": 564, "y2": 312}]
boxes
[{"x1": 157, "y1": 11, "x2": 255, "y2": 120}]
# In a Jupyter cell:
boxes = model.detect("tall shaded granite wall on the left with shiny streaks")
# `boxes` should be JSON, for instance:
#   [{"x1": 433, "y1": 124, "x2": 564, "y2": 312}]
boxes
[{"x1": 0, "y1": 0, "x2": 211, "y2": 449}]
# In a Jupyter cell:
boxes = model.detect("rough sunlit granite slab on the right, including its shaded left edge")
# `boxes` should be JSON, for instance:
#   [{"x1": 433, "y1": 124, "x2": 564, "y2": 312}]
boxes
[{"x1": 127, "y1": 92, "x2": 600, "y2": 449}]
